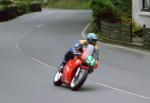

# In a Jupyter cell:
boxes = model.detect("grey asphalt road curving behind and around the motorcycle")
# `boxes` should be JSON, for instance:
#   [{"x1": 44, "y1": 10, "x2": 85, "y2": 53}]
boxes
[{"x1": 0, "y1": 9, "x2": 150, "y2": 103}]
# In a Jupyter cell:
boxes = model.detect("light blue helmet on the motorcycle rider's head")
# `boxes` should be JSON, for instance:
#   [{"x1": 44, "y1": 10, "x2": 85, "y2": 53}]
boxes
[{"x1": 86, "y1": 33, "x2": 97, "y2": 44}]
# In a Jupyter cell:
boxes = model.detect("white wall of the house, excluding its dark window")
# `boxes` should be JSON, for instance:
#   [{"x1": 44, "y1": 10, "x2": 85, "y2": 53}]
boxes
[{"x1": 132, "y1": 0, "x2": 150, "y2": 28}]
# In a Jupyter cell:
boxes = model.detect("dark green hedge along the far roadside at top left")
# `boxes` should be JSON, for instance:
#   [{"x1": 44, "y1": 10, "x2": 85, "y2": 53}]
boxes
[{"x1": 0, "y1": 1, "x2": 41, "y2": 21}]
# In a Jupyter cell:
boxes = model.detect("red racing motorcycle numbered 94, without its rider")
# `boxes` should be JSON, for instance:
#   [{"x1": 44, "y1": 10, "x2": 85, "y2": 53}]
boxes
[{"x1": 53, "y1": 44, "x2": 99, "y2": 91}]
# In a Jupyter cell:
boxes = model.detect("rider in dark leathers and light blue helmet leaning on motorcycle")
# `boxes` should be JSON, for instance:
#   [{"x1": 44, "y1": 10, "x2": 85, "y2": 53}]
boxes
[{"x1": 58, "y1": 33, "x2": 99, "y2": 72}]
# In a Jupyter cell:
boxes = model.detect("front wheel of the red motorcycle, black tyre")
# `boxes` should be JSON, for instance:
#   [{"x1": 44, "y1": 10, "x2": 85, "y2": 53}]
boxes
[{"x1": 70, "y1": 67, "x2": 88, "y2": 91}]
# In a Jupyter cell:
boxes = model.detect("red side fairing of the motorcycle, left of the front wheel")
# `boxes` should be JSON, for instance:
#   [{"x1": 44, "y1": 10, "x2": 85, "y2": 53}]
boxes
[{"x1": 62, "y1": 58, "x2": 83, "y2": 84}]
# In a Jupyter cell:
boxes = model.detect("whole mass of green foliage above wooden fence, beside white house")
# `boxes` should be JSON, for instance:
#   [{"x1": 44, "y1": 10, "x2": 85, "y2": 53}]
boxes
[{"x1": 91, "y1": 0, "x2": 132, "y2": 32}]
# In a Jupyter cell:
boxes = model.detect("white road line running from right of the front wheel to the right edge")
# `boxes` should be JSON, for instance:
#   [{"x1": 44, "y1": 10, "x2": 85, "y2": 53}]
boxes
[{"x1": 96, "y1": 83, "x2": 150, "y2": 100}]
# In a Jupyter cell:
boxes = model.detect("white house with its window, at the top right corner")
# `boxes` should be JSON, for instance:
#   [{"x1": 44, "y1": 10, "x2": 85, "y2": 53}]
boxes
[{"x1": 132, "y1": 0, "x2": 150, "y2": 28}]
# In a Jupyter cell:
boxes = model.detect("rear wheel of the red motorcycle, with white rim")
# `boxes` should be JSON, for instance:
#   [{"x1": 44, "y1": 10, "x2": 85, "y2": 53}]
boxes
[{"x1": 53, "y1": 71, "x2": 62, "y2": 86}]
